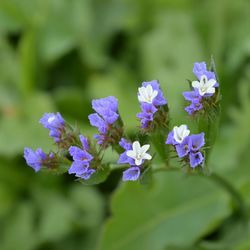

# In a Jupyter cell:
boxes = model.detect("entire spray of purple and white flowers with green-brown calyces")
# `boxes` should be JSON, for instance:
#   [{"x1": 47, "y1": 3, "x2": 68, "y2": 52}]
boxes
[{"x1": 24, "y1": 59, "x2": 220, "y2": 184}]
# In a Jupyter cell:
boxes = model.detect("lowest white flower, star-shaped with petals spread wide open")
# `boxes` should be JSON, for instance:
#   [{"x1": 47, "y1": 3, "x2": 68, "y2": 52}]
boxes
[{"x1": 126, "y1": 141, "x2": 152, "y2": 166}]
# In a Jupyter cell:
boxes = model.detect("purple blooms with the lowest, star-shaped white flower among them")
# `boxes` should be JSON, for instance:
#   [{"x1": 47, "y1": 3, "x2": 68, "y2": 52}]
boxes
[{"x1": 118, "y1": 138, "x2": 152, "y2": 181}]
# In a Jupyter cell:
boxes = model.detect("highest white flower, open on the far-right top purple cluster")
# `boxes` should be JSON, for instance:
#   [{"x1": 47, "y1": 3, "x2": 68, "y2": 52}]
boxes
[{"x1": 192, "y1": 75, "x2": 216, "y2": 96}]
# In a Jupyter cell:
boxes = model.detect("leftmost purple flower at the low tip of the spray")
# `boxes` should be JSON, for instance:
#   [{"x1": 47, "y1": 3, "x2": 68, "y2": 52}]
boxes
[{"x1": 24, "y1": 148, "x2": 54, "y2": 172}]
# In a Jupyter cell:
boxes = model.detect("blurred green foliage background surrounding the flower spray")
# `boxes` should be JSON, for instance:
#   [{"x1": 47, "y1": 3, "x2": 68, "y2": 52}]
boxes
[{"x1": 0, "y1": 0, "x2": 250, "y2": 250}]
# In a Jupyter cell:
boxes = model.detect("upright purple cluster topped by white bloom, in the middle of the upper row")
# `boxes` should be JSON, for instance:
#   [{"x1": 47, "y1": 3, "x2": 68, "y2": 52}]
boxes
[{"x1": 137, "y1": 80, "x2": 167, "y2": 131}]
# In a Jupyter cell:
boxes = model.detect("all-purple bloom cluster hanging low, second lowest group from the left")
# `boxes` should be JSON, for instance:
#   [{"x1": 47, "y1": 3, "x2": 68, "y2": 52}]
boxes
[{"x1": 68, "y1": 135, "x2": 96, "y2": 180}]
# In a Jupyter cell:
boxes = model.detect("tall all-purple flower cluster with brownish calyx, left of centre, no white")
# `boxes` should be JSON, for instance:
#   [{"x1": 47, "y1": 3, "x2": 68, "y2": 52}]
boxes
[{"x1": 89, "y1": 96, "x2": 123, "y2": 148}]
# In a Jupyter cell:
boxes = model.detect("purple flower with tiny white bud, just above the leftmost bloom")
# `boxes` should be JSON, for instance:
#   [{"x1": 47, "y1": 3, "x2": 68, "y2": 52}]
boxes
[{"x1": 39, "y1": 112, "x2": 65, "y2": 142}]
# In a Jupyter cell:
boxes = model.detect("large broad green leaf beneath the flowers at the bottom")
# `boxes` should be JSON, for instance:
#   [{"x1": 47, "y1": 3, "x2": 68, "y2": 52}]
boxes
[{"x1": 100, "y1": 172, "x2": 230, "y2": 250}]
